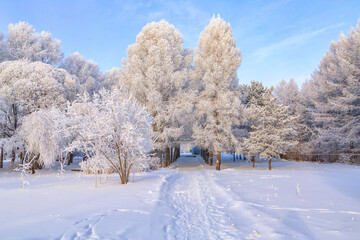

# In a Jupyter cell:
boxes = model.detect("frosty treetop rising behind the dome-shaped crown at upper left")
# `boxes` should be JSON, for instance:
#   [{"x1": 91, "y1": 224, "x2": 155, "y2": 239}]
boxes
[{"x1": 7, "y1": 22, "x2": 63, "y2": 64}]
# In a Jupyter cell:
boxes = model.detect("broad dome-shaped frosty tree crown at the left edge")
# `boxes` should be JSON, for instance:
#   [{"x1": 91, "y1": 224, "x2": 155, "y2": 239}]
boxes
[{"x1": 0, "y1": 60, "x2": 79, "y2": 113}]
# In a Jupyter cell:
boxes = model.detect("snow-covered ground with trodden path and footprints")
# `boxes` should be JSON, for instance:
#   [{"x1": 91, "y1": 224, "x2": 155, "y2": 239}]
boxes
[{"x1": 0, "y1": 157, "x2": 360, "y2": 240}]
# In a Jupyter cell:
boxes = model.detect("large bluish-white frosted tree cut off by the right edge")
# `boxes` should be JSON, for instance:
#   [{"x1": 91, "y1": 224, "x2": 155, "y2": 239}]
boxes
[{"x1": 311, "y1": 19, "x2": 360, "y2": 160}]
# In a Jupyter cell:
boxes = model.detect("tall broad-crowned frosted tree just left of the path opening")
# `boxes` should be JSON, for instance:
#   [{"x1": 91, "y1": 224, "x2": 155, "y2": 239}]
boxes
[{"x1": 119, "y1": 20, "x2": 191, "y2": 166}]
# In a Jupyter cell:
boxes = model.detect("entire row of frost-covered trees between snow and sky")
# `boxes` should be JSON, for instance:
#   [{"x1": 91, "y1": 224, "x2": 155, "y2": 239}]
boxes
[{"x1": 0, "y1": 16, "x2": 360, "y2": 183}]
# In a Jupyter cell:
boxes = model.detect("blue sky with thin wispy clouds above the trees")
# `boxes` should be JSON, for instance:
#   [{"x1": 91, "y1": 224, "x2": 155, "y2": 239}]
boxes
[{"x1": 0, "y1": 0, "x2": 360, "y2": 86}]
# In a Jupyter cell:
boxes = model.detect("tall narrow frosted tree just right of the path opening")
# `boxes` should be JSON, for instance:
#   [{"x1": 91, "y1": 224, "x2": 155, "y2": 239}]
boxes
[{"x1": 193, "y1": 17, "x2": 241, "y2": 170}]
